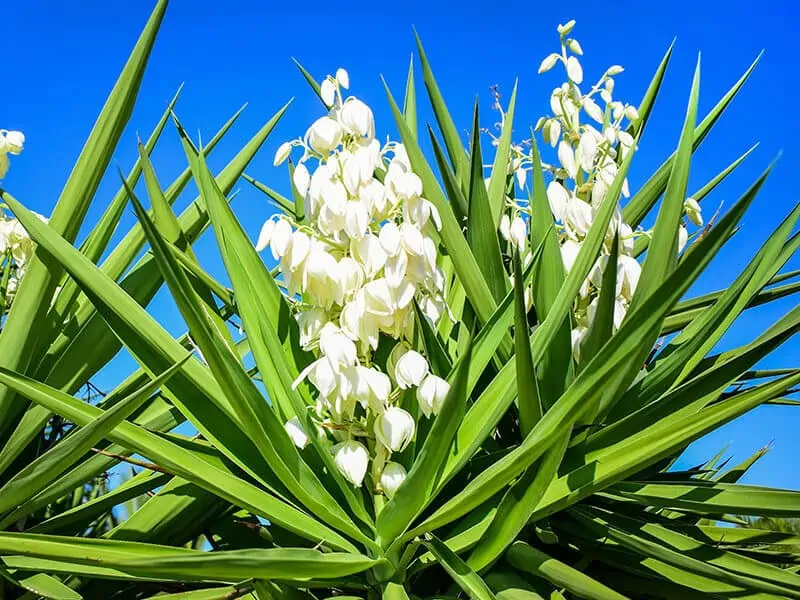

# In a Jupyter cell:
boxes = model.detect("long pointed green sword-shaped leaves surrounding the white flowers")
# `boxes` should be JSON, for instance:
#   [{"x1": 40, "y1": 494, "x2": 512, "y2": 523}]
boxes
[{"x1": 0, "y1": 0, "x2": 800, "y2": 600}]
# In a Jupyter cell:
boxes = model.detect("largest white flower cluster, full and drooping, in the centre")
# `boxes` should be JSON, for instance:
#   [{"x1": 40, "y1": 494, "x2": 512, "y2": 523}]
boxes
[{"x1": 256, "y1": 69, "x2": 448, "y2": 496}]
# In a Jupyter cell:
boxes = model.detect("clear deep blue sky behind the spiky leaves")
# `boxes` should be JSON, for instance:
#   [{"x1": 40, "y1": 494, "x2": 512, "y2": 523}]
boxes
[{"x1": 0, "y1": 0, "x2": 800, "y2": 488}]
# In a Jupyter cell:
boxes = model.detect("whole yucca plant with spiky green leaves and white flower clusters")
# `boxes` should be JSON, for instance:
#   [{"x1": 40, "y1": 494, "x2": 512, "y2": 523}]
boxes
[{"x1": 0, "y1": 0, "x2": 800, "y2": 600}]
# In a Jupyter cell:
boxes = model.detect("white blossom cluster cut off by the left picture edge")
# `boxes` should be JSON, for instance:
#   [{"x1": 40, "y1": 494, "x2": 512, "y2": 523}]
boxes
[{"x1": 0, "y1": 129, "x2": 35, "y2": 308}]
